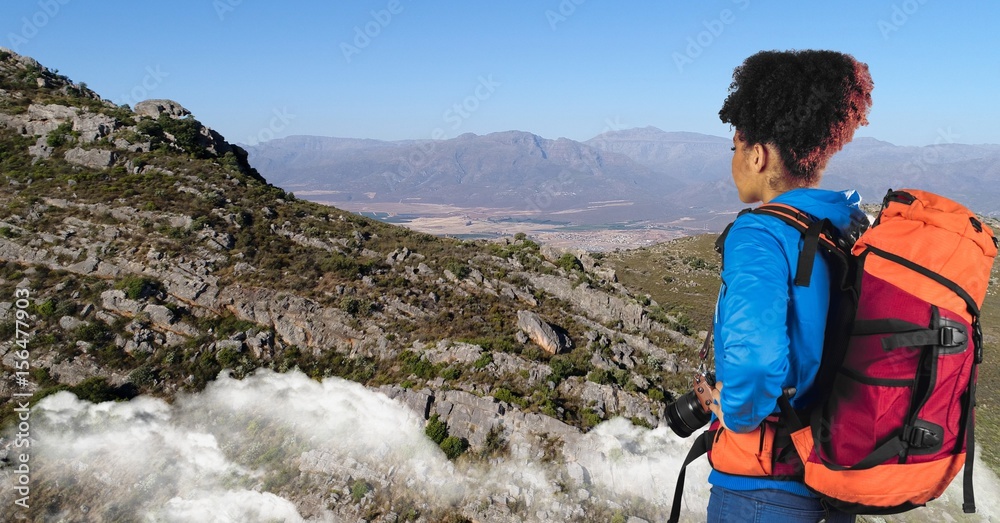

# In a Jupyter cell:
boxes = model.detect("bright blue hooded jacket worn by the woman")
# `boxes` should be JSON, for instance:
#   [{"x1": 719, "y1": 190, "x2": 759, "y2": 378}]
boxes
[{"x1": 709, "y1": 189, "x2": 865, "y2": 495}]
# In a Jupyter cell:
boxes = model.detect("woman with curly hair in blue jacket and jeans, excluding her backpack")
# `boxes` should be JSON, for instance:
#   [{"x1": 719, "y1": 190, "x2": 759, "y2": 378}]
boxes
[{"x1": 708, "y1": 51, "x2": 873, "y2": 523}]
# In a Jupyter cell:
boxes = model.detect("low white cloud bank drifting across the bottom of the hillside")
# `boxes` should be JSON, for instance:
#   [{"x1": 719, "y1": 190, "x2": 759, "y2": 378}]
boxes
[{"x1": 0, "y1": 371, "x2": 1000, "y2": 522}]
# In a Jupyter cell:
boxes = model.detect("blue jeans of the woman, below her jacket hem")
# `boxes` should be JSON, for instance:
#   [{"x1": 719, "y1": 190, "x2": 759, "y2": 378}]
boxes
[{"x1": 708, "y1": 486, "x2": 854, "y2": 523}]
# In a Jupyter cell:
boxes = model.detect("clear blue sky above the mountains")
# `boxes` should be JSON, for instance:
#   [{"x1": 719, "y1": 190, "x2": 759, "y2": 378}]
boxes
[{"x1": 0, "y1": 0, "x2": 1000, "y2": 145}]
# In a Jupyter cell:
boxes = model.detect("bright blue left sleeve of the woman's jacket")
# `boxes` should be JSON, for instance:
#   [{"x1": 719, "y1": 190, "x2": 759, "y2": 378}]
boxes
[{"x1": 715, "y1": 222, "x2": 789, "y2": 432}]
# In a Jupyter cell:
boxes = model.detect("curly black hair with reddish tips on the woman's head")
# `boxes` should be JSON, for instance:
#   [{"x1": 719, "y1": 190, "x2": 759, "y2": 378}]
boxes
[{"x1": 719, "y1": 50, "x2": 874, "y2": 186}]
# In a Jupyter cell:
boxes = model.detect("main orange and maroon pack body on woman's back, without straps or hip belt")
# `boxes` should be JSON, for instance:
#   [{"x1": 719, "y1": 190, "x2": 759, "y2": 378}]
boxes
[{"x1": 792, "y1": 189, "x2": 997, "y2": 514}]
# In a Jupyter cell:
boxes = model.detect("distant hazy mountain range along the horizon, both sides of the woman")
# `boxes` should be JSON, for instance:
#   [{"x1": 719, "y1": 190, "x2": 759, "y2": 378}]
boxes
[{"x1": 247, "y1": 127, "x2": 1000, "y2": 228}]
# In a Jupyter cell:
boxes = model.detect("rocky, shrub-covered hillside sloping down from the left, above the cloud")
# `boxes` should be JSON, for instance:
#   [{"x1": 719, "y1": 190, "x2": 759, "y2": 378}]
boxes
[{"x1": 0, "y1": 50, "x2": 712, "y2": 521}]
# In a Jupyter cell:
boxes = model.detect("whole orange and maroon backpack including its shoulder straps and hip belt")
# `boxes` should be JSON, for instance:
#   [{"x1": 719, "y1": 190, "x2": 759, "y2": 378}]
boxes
[{"x1": 669, "y1": 189, "x2": 997, "y2": 522}]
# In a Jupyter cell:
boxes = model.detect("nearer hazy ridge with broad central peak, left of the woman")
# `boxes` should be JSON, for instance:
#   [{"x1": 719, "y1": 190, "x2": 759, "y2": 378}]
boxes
[{"x1": 248, "y1": 131, "x2": 683, "y2": 223}]
